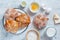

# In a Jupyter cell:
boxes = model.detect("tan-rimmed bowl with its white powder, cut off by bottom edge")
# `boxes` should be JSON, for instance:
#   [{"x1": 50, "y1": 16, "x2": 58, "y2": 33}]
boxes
[{"x1": 26, "y1": 29, "x2": 40, "y2": 40}]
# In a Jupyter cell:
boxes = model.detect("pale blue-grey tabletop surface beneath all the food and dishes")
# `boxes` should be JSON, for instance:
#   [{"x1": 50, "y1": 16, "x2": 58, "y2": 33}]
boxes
[{"x1": 0, "y1": 0, "x2": 60, "y2": 40}]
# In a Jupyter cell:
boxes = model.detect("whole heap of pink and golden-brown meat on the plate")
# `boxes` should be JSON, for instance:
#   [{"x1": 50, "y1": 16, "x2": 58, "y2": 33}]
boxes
[{"x1": 4, "y1": 8, "x2": 30, "y2": 33}]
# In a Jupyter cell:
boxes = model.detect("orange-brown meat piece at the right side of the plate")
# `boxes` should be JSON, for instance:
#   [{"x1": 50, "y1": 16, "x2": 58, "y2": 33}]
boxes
[{"x1": 16, "y1": 14, "x2": 30, "y2": 23}]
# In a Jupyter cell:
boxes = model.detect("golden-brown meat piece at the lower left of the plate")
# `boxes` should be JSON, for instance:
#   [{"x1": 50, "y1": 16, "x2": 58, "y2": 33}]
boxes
[{"x1": 4, "y1": 20, "x2": 18, "y2": 33}]
